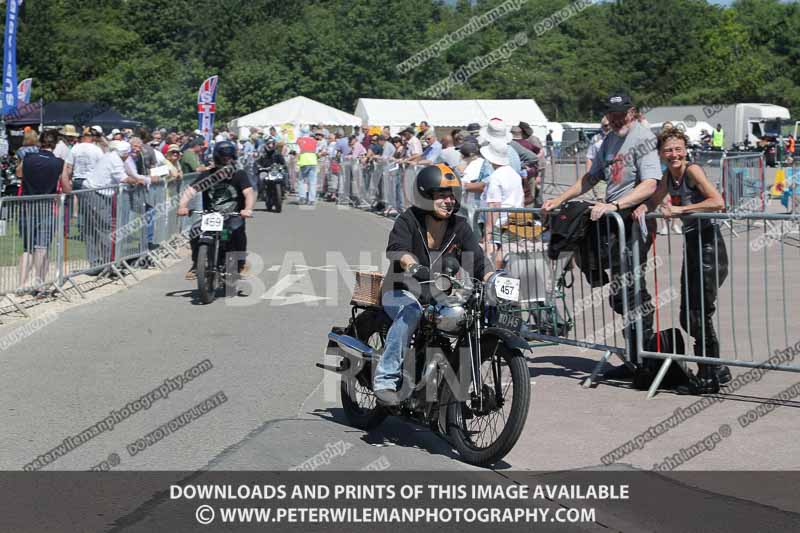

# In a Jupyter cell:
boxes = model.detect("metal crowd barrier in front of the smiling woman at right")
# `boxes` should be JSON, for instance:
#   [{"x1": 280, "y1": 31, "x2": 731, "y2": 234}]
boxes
[{"x1": 633, "y1": 213, "x2": 800, "y2": 397}]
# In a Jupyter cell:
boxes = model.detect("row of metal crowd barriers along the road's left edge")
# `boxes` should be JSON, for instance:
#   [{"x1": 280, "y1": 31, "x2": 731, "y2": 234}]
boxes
[{"x1": 0, "y1": 180, "x2": 194, "y2": 306}]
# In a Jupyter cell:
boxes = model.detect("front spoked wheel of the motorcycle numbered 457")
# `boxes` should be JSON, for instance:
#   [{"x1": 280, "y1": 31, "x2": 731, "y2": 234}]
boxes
[{"x1": 447, "y1": 339, "x2": 530, "y2": 466}]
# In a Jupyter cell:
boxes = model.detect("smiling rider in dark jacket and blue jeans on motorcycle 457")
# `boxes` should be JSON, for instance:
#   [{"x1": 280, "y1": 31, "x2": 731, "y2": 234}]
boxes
[{"x1": 374, "y1": 164, "x2": 494, "y2": 405}]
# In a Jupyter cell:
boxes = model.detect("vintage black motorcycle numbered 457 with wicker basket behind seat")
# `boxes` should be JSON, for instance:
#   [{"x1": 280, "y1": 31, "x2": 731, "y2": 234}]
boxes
[{"x1": 317, "y1": 269, "x2": 530, "y2": 466}]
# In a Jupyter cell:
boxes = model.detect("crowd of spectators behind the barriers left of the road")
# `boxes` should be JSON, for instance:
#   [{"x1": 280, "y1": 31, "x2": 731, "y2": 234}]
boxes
[{"x1": 11, "y1": 125, "x2": 219, "y2": 287}]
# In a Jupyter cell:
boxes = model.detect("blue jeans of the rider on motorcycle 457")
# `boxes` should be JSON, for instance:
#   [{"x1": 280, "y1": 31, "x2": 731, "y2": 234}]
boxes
[{"x1": 373, "y1": 291, "x2": 422, "y2": 390}]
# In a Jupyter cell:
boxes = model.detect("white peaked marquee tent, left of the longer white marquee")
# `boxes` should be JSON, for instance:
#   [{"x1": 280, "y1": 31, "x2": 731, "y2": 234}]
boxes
[{"x1": 228, "y1": 96, "x2": 361, "y2": 128}]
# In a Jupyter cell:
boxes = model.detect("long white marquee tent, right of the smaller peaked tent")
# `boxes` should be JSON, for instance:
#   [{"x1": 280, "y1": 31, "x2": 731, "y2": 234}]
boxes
[{"x1": 355, "y1": 98, "x2": 548, "y2": 129}]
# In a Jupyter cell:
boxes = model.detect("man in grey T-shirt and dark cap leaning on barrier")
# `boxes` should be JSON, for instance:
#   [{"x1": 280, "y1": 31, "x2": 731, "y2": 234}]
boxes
[{"x1": 542, "y1": 93, "x2": 661, "y2": 377}]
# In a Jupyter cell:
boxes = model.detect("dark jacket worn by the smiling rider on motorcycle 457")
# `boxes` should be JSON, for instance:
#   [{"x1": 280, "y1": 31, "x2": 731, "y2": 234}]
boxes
[{"x1": 381, "y1": 207, "x2": 494, "y2": 298}]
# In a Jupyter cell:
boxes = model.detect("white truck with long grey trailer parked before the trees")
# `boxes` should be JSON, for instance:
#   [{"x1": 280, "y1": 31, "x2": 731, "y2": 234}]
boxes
[{"x1": 645, "y1": 104, "x2": 790, "y2": 149}]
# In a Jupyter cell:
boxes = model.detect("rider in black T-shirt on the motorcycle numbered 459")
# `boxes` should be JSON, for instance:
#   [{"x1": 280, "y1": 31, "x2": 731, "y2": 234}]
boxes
[{"x1": 178, "y1": 137, "x2": 256, "y2": 279}]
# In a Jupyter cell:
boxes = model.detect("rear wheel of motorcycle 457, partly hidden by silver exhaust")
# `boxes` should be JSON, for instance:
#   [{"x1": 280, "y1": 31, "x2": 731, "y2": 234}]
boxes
[{"x1": 340, "y1": 309, "x2": 388, "y2": 430}]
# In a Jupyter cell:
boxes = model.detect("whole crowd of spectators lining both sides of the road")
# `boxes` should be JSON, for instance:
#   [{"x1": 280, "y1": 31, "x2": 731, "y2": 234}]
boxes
[{"x1": 6, "y1": 119, "x2": 544, "y2": 286}]
